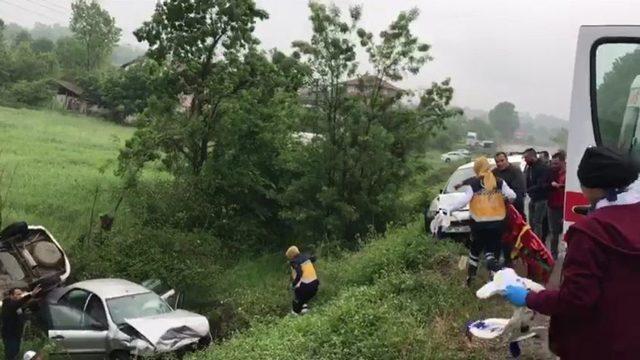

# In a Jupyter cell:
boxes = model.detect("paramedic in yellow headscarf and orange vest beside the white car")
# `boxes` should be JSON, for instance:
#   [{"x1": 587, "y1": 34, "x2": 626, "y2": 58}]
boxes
[{"x1": 441, "y1": 157, "x2": 516, "y2": 286}]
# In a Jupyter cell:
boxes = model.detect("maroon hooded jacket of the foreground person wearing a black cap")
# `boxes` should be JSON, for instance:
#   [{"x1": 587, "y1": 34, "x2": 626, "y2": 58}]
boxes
[{"x1": 527, "y1": 203, "x2": 640, "y2": 360}]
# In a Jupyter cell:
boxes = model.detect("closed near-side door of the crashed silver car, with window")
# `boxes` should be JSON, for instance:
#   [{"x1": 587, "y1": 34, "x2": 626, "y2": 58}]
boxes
[{"x1": 47, "y1": 289, "x2": 108, "y2": 360}]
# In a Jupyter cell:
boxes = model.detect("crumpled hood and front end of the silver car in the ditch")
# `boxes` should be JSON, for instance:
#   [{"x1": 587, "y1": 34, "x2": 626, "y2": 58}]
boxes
[{"x1": 125, "y1": 310, "x2": 209, "y2": 355}]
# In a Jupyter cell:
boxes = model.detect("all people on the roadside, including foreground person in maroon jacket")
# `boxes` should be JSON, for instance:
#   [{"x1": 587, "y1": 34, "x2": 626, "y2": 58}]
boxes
[{"x1": 445, "y1": 147, "x2": 640, "y2": 360}]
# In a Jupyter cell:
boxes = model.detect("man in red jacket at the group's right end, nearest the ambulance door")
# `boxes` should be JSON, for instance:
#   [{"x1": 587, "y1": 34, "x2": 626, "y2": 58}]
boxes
[{"x1": 547, "y1": 151, "x2": 567, "y2": 260}]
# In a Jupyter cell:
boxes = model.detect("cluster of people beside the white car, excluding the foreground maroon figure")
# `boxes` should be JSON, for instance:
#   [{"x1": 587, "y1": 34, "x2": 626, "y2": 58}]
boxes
[{"x1": 450, "y1": 148, "x2": 566, "y2": 286}]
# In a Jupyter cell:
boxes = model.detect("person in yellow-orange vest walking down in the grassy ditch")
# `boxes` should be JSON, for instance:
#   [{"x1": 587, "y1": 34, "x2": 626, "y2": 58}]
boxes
[{"x1": 286, "y1": 246, "x2": 320, "y2": 315}]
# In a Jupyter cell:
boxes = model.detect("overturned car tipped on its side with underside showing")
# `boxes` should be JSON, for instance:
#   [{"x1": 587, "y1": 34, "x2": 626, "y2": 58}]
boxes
[{"x1": 0, "y1": 222, "x2": 71, "y2": 304}]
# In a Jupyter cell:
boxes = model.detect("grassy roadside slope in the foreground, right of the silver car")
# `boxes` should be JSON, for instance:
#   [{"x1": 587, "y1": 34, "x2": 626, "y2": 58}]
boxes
[{"x1": 192, "y1": 221, "x2": 508, "y2": 359}]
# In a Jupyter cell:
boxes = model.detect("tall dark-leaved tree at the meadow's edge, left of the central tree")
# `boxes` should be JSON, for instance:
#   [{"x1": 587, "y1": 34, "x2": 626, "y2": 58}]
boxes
[{"x1": 129, "y1": 0, "x2": 267, "y2": 174}]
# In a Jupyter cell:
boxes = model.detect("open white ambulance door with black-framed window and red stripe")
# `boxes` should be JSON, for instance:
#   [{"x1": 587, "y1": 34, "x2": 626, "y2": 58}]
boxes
[{"x1": 565, "y1": 26, "x2": 640, "y2": 230}]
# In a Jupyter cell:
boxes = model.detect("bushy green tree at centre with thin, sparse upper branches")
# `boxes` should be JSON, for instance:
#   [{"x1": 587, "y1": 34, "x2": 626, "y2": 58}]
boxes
[{"x1": 285, "y1": 2, "x2": 455, "y2": 239}]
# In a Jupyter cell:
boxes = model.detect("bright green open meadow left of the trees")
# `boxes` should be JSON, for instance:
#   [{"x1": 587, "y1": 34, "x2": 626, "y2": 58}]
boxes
[{"x1": 0, "y1": 107, "x2": 134, "y2": 244}]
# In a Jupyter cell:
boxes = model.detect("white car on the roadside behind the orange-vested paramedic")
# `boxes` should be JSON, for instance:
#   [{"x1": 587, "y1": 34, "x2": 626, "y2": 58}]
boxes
[{"x1": 425, "y1": 156, "x2": 526, "y2": 241}]
